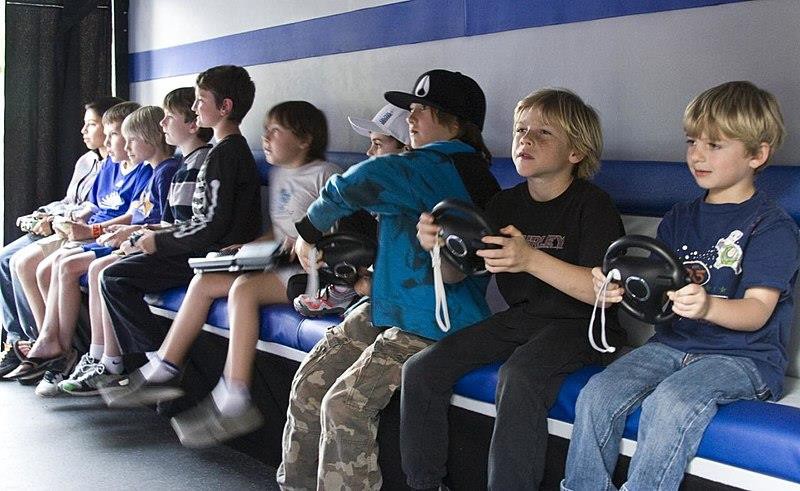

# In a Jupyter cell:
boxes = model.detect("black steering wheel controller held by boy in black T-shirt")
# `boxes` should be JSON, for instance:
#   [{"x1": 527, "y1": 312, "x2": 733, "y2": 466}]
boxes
[{"x1": 431, "y1": 199, "x2": 498, "y2": 275}]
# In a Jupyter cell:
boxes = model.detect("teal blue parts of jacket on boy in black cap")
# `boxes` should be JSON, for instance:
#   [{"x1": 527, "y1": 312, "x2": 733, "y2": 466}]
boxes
[{"x1": 298, "y1": 140, "x2": 497, "y2": 340}]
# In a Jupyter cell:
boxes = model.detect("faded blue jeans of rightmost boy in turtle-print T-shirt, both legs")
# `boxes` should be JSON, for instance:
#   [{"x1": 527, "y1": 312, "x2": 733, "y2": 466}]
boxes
[{"x1": 561, "y1": 343, "x2": 769, "y2": 491}]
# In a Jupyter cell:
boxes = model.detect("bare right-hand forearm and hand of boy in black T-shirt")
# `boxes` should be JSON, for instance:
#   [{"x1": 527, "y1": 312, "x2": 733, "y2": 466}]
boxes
[{"x1": 478, "y1": 225, "x2": 595, "y2": 304}]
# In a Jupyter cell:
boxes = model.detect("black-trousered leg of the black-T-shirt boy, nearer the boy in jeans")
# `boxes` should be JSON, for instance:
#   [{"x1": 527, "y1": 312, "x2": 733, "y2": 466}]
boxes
[{"x1": 488, "y1": 318, "x2": 596, "y2": 491}]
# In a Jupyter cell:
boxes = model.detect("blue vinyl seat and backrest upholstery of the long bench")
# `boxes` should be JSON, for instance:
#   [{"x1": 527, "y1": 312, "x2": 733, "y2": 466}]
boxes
[{"x1": 148, "y1": 158, "x2": 800, "y2": 482}]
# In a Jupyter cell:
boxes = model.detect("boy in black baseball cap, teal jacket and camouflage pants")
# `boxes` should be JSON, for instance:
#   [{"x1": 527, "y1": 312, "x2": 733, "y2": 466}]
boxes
[{"x1": 278, "y1": 70, "x2": 499, "y2": 489}]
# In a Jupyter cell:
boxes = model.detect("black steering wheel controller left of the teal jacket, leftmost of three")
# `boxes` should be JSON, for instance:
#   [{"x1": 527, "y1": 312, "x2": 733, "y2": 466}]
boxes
[{"x1": 316, "y1": 233, "x2": 378, "y2": 286}]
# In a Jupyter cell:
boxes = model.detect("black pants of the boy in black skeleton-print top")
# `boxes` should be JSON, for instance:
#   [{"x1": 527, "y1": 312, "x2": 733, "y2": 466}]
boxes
[{"x1": 101, "y1": 254, "x2": 194, "y2": 354}]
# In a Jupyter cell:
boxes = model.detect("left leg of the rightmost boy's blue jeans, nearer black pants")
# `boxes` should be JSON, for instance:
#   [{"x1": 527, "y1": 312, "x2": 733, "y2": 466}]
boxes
[{"x1": 561, "y1": 342, "x2": 683, "y2": 491}]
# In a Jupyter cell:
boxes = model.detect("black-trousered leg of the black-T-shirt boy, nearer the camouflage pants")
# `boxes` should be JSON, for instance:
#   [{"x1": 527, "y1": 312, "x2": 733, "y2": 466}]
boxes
[{"x1": 400, "y1": 316, "x2": 530, "y2": 489}]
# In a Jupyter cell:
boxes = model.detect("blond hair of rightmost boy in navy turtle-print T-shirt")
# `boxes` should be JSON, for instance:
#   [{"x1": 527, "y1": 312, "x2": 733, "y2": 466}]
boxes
[{"x1": 683, "y1": 82, "x2": 786, "y2": 167}]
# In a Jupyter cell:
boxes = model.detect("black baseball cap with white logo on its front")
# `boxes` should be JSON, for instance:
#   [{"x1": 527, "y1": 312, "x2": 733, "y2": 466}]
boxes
[{"x1": 383, "y1": 70, "x2": 486, "y2": 130}]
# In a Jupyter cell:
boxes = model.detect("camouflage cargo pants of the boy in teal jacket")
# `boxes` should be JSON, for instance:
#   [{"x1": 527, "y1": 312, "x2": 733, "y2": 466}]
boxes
[{"x1": 277, "y1": 304, "x2": 431, "y2": 490}]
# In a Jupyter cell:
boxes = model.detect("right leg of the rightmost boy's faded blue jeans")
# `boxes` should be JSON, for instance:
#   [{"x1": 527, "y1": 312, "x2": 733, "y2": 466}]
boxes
[{"x1": 626, "y1": 354, "x2": 768, "y2": 489}]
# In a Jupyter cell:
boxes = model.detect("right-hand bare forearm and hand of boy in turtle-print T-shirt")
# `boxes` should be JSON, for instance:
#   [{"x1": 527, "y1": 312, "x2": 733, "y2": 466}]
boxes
[{"x1": 668, "y1": 283, "x2": 780, "y2": 331}]
